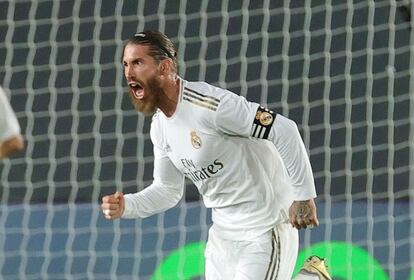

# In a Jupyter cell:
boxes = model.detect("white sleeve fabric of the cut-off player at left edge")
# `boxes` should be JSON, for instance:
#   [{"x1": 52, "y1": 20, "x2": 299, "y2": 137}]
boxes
[{"x1": 0, "y1": 87, "x2": 20, "y2": 142}]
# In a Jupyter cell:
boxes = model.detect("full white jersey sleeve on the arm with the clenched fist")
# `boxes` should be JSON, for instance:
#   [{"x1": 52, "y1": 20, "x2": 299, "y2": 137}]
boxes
[{"x1": 122, "y1": 116, "x2": 184, "y2": 218}]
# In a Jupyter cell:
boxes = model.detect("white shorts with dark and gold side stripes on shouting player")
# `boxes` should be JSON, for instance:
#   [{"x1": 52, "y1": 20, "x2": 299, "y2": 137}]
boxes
[{"x1": 205, "y1": 224, "x2": 299, "y2": 280}]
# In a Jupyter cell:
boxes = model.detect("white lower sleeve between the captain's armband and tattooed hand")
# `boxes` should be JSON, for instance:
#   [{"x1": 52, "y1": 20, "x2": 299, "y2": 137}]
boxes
[{"x1": 268, "y1": 114, "x2": 316, "y2": 201}]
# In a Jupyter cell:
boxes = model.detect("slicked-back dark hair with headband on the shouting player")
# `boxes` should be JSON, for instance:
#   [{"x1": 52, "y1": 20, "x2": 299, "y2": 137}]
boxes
[{"x1": 124, "y1": 30, "x2": 178, "y2": 72}]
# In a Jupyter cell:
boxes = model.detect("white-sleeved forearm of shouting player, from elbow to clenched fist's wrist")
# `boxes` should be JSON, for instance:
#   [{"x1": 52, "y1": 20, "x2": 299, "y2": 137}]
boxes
[{"x1": 122, "y1": 183, "x2": 184, "y2": 218}]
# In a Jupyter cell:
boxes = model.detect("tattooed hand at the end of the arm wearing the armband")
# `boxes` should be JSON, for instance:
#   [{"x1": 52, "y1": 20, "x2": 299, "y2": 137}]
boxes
[{"x1": 289, "y1": 199, "x2": 319, "y2": 229}]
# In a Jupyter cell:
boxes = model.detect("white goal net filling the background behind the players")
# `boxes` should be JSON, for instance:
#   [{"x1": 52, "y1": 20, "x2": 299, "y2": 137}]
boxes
[{"x1": 0, "y1": 0, "x2": 414, "y2": 280}]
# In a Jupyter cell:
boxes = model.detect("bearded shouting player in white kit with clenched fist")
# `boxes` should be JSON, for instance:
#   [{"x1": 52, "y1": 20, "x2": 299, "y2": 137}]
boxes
[{"x1": 101, "y1": 31, "x2": 332, "y2": 280}]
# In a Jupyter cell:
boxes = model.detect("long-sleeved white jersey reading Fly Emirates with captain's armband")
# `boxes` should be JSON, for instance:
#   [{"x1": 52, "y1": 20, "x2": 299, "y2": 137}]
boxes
[{"x1": 123, "y1": 80, "x2": 316, "y2": 240}]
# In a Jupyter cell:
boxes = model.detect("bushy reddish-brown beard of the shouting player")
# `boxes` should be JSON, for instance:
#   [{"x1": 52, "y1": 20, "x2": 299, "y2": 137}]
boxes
[{"x1": 128, "y1": 74, "x2": 163, "y2": 116}]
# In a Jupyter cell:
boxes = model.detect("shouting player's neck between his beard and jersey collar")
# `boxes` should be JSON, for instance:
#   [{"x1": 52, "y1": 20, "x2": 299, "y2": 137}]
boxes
[{"x1": 158, "y1": 76, "x2": 180, "y2": 117}]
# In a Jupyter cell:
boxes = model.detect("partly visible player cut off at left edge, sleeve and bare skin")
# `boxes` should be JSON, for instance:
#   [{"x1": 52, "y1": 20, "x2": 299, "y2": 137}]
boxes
[{"x1": 0, "y1": 87, "x2": 24, "y2": 159}]
